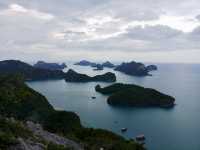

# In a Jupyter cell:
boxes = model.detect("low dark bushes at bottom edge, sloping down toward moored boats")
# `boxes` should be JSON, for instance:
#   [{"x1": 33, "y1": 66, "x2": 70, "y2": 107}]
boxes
[{"x1": 74, "y1": 128, "x2": 144, "y2": 150}]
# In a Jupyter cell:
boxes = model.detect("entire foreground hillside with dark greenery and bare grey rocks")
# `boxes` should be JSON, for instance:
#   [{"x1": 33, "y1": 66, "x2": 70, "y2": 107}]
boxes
[{"x1": 0, "y1": 74, "x2": 144, "y2": 150}]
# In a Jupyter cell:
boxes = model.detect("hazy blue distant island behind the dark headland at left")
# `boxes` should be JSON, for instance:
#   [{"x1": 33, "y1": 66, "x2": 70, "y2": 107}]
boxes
[{"x1": 33, "y1": 61, "x2": 67, "y2": 70}]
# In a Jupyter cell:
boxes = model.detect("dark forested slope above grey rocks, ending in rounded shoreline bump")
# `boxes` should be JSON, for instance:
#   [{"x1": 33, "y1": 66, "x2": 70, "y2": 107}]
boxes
[{"x1": 0, "y1": 76, "x2": 81, "y2": 132}]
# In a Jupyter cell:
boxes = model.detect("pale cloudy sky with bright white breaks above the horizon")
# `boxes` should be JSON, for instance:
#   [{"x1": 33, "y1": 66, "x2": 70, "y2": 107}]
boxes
[{"x1": 0, "y1": 0, "x2": 200, "y2": 63}]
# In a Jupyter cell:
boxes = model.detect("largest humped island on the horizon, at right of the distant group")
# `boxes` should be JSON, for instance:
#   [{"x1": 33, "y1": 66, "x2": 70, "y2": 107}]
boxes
[{"x1": 114, "y1": 61, "x2": 158, "y2": 76}]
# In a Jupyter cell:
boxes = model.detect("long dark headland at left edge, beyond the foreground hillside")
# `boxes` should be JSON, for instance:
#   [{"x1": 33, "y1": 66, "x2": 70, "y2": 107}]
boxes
[{"x1": 0, "y1": 60, "x2": 65, "y2": 81}]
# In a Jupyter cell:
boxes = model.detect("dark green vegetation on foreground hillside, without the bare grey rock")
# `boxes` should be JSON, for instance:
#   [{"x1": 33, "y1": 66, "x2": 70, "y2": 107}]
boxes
[{"x1": 0, "y1": 75, "x2": 143, "y2": 150}]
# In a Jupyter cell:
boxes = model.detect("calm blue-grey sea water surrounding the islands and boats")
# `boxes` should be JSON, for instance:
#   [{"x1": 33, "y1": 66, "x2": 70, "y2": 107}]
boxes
[{"x1": 27, "y1": 64, "x2": 200, "y2": 150}]
